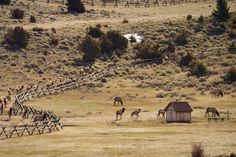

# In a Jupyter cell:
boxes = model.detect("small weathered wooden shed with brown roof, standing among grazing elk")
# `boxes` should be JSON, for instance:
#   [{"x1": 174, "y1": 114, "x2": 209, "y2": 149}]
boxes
[{"x1": 165, "y1": 102, "x2": 193, "y2": 123}]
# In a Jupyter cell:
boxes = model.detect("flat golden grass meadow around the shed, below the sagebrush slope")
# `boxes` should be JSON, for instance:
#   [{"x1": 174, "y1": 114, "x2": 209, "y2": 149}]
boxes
[{"x1": 0, "y1": 80, "x2": 236, "y2": 157}]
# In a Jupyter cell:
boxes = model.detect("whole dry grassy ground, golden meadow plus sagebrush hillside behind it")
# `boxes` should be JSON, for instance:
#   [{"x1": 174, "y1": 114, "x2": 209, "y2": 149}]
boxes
[{"x1": 0, "y1": 0, "x2": 236, "y2": 157}]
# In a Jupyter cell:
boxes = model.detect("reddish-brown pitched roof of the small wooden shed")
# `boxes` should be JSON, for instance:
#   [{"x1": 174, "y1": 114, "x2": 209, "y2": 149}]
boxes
[{"x1": 165, "y1": 102, "x2": 193, "y2": 112}]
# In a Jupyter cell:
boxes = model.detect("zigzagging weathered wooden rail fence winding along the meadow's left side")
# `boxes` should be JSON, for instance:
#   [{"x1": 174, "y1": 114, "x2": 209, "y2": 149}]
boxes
[{"x1": 0, "y1": 72, "x2": 106, "y2": 139}]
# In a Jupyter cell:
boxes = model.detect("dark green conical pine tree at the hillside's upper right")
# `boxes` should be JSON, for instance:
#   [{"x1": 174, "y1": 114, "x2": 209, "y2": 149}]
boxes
[{"x1": 212, "y1": 0, "x2": 230, "y2": 21}]
